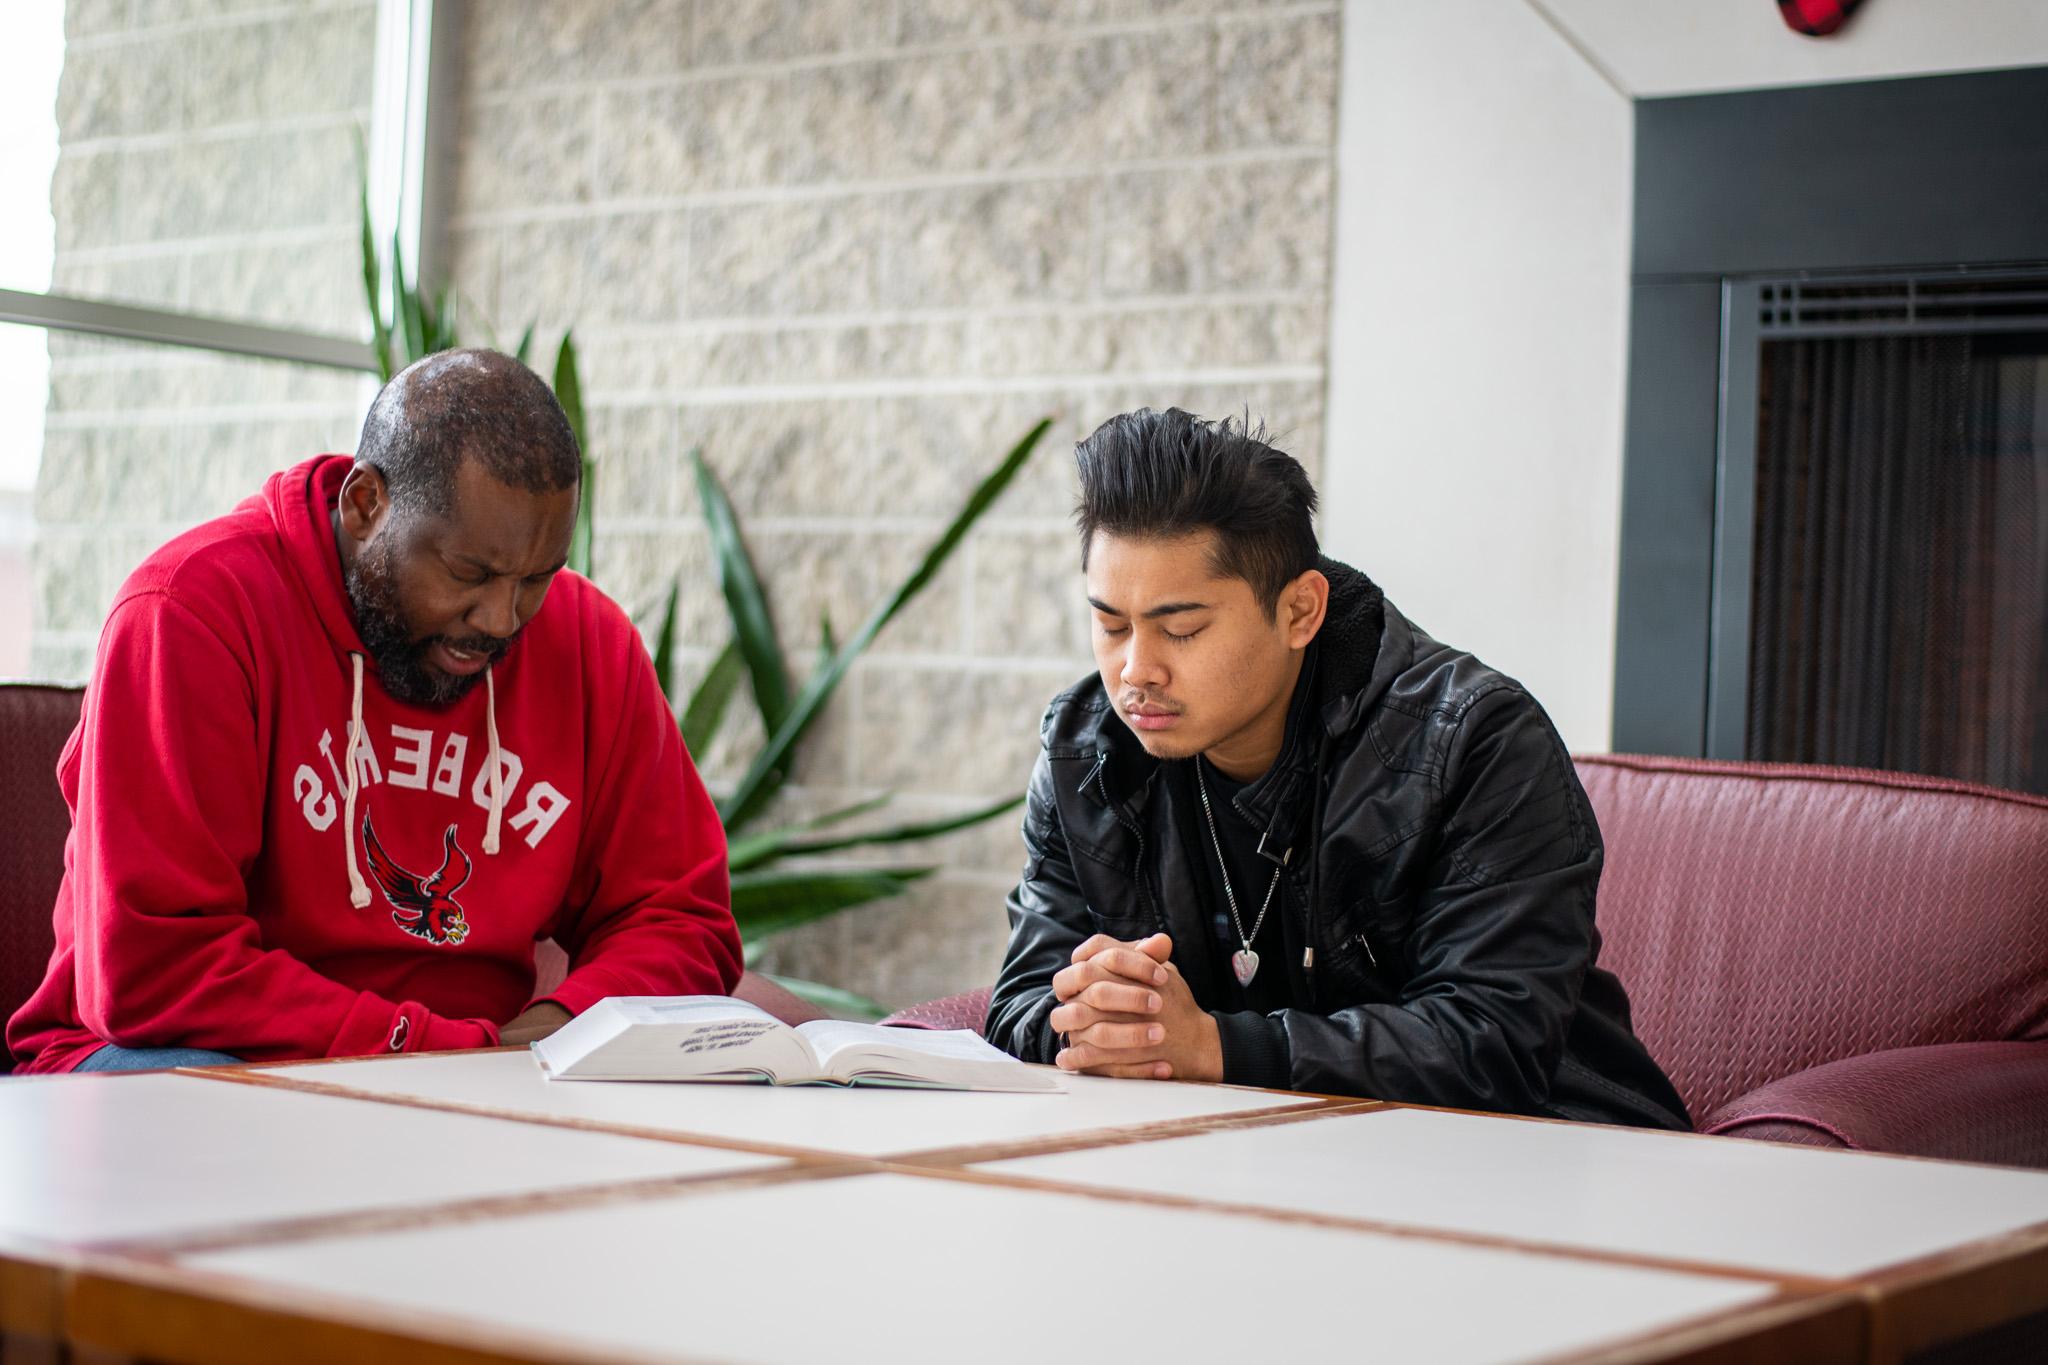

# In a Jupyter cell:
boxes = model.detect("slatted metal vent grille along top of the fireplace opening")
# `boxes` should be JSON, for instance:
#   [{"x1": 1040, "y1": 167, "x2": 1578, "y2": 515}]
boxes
[{"x1": 1757, "y1": 266, "x2": 2048, "y2": 338}]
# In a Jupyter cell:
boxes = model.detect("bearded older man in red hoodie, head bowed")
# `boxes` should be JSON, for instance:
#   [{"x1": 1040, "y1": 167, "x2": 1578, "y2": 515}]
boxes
[{"x1": 6, "y1": 350, "x2": 739, "y2": 1072}]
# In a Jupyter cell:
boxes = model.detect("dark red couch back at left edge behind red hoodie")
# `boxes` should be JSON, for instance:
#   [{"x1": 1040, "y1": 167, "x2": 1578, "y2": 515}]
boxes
[{"x1": 0, "y1": 684, "x2": 84, "y2": 1068}]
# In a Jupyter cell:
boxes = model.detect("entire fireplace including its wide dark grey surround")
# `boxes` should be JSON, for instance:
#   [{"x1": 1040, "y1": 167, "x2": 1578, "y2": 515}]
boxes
[{"x1": 1614, "y1": 70, "x2": 2048, "y2": 790}]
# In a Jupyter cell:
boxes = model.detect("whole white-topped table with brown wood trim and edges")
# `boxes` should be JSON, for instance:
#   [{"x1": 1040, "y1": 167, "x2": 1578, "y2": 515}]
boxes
[{"x1": 0, "y1": 1052, "x2": 2048, "y2": 1361}]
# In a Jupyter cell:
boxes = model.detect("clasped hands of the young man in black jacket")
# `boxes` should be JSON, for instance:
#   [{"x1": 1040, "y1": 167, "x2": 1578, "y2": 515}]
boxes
[{"x1": 1053, "y1": 933, "x2": 1223, "y2": 1081}]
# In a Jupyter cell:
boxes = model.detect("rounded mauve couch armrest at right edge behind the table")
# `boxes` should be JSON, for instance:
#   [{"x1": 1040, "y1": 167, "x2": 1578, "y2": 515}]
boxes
[{"x1": 1700, "y1": 1042, "x2": 2048, "y2": 1166}]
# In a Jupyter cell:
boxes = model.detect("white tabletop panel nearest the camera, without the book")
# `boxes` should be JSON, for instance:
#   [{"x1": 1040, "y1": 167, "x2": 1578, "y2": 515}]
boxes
[{"x1": 167, "y1": 1175, "x2": 1774, "y2": 1365}]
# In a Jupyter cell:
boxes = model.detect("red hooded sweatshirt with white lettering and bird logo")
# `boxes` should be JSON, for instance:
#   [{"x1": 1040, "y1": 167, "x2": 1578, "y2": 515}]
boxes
[{"x1": 6, "y1": 456, "x2": 739, "y2": 1072}]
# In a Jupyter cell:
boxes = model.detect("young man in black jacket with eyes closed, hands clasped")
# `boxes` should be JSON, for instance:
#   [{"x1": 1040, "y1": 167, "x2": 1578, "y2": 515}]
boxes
[{"x1": 987, "y1": 409, "x2": 1690, "y2": 1128}]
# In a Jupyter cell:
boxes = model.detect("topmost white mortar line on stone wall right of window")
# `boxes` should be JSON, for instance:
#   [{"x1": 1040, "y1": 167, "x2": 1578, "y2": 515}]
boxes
[{"x1": 463, "y1": 0, "x2": 1341, "y2": 108}]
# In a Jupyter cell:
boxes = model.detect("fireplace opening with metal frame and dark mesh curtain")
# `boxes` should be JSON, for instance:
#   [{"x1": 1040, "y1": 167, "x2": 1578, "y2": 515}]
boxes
[{"x1": 1708, "y1": 270, "x2": 2048, "y2": 792}]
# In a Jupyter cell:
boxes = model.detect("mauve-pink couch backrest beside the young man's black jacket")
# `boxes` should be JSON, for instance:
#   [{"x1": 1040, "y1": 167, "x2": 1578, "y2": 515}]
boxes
[{"x1": 1577, "y1": 755, "x2": 2048, "y2": 1115}]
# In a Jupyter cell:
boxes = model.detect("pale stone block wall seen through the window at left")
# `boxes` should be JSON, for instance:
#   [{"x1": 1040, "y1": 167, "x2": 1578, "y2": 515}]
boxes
[{"x1": 29, "y1": 0, "x2": 377, "y2": 681}]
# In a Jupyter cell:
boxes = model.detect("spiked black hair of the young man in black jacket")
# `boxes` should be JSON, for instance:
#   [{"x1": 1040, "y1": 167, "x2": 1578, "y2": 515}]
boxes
[{"x1": 1073, "y1": 407, "x2": 1317, "y2": 618}]
